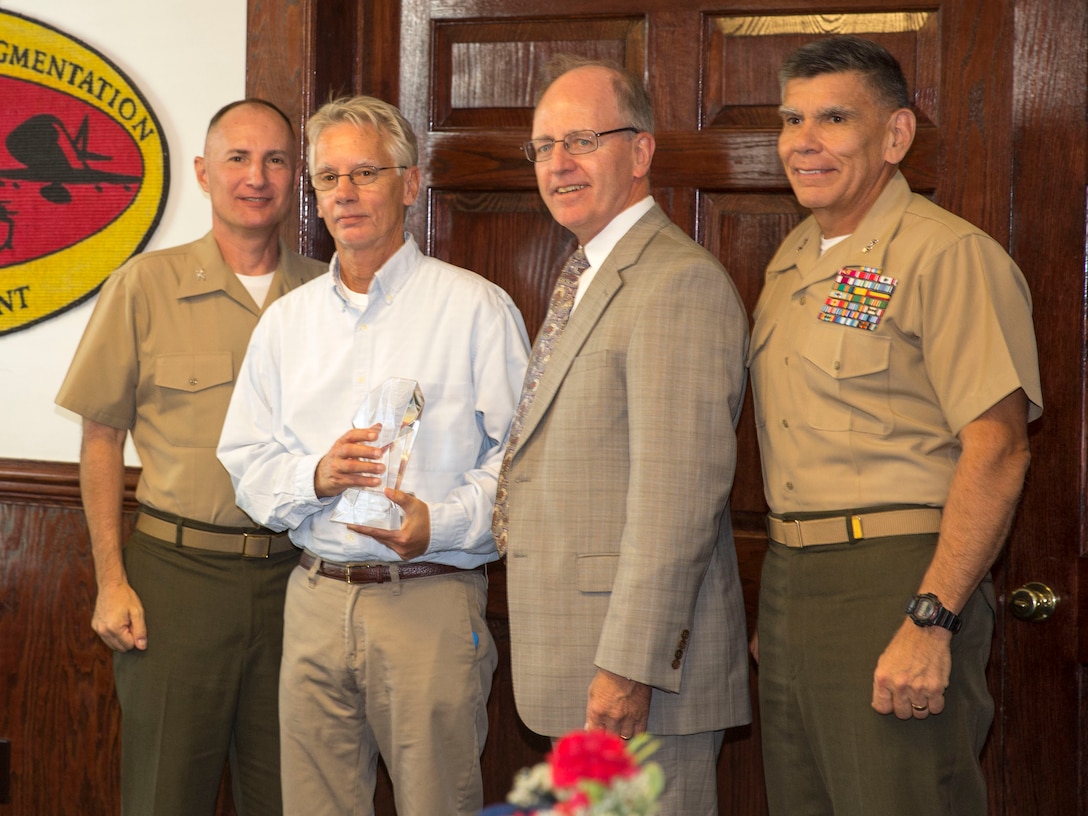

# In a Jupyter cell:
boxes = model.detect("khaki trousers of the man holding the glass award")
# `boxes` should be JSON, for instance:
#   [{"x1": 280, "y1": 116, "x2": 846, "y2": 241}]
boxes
[{"x1": 280, "y1": 561, "x2": 497, "y2": 816}]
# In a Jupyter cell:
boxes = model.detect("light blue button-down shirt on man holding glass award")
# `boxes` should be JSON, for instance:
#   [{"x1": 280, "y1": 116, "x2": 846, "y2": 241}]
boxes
[{"x1": 218, "y1": 236, "x2": 529, "y2": 568}]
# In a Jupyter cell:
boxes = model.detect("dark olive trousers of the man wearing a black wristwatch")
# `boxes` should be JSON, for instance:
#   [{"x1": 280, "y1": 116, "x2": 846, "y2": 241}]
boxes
[{"x1": 758, "y1": 535, "x2": 994, "y2": 816}]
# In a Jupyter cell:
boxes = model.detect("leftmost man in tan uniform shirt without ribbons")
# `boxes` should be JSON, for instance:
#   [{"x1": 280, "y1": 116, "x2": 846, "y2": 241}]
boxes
[{"x1": 57, "y1": 100, "x2": 324, "y2": 816}]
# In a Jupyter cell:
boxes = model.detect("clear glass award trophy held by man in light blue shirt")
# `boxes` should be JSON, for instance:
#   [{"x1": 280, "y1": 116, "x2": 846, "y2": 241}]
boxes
[{"x1": 332, "y1": 378, "x2": 423, "y2": 530}]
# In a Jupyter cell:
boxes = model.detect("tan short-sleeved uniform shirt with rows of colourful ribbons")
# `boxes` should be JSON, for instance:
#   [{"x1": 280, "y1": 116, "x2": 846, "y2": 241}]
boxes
[{"x1": 749, "y1": 173, "x2": 1042, "y2": 514}]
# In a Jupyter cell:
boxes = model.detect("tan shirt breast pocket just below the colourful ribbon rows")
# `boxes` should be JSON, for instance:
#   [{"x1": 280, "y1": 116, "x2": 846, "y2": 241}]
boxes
[{"x1": 802, "y1": 324, "x2": 892, "y2": 434}]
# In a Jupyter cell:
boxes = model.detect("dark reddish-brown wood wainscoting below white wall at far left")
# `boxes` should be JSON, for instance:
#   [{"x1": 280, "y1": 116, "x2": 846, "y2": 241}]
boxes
[{"x1": 0, "y1": 460, "x2": 136, "y2": 816}]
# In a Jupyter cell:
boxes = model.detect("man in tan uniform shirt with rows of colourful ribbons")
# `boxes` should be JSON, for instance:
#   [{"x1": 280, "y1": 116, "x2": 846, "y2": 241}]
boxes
[{"x1": 749, "y1": 37, "x2": 1042, "y2": 816}]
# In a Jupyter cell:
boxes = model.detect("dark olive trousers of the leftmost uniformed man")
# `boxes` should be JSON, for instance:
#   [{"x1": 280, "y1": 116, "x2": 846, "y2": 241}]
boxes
[{"x1": 113, "y1": 532, "x2": 298, "y2": 816}]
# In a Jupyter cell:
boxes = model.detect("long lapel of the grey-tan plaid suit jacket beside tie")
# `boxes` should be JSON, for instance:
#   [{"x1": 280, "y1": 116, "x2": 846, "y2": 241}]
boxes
[{"x1": 515, "y1": 205, "x2": 670, "y2": 448}]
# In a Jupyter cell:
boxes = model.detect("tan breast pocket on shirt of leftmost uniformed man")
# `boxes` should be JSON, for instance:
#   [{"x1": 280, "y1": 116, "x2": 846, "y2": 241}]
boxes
[{"x1": 152, "y1": 351, "x2": 234, "y2": 447}]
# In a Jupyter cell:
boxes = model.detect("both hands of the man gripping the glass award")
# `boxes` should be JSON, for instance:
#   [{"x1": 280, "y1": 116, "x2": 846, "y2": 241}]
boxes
[{"x1": 313, "y1": 425, "x2": 431, "y2": 561}]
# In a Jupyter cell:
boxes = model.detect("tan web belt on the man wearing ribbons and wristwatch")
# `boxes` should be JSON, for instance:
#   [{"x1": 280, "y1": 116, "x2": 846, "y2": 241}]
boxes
[{"x1": 767, "y1": 507, "x2": 941, "y2": 547}]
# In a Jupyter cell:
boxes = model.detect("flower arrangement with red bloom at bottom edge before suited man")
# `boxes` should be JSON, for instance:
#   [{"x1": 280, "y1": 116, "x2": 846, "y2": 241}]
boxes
[{"x1": 496, "y1": 731, "x2": 665, "y2": 816}]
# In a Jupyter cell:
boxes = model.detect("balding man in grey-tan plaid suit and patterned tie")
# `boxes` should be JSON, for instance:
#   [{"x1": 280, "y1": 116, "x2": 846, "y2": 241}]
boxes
[{"x1": 494, "y1": 54, "x2": 751, "y2": 816}]
